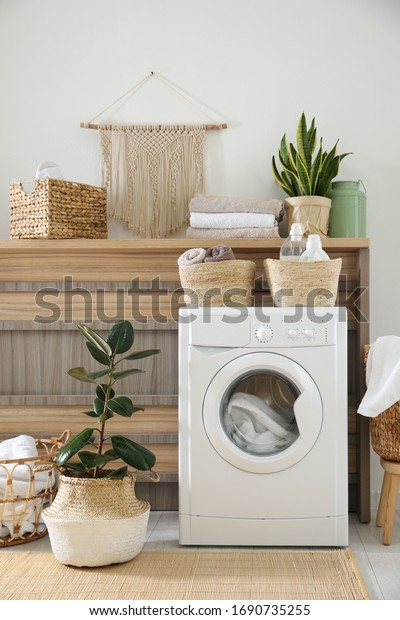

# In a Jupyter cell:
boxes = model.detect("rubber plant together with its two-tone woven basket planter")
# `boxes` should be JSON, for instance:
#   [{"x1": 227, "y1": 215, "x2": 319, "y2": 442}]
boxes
[{"x1": 43, "y1": 321, "x2": 159, "y2": 566}]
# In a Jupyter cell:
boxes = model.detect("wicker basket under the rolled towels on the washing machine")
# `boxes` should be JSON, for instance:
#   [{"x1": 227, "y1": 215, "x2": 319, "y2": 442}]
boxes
[{"x1": 179, "y1": 260, "x2": 256, "y2": 307}]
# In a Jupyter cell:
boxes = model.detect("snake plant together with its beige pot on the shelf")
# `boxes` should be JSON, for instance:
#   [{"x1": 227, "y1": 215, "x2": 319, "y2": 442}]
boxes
[{"x1": 272, "y1": 112, "x2": 350, "y2": 236}]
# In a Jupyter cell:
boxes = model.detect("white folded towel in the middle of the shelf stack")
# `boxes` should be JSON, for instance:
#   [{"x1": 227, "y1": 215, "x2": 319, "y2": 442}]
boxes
[{"x1": 190, "y1": 212, "x2": 275, "y2": 228}]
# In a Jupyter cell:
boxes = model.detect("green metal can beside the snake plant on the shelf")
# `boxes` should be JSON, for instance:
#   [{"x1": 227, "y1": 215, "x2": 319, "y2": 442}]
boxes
[{"x1": 328, "y1": 180, "x2": 367, "y2": 237}]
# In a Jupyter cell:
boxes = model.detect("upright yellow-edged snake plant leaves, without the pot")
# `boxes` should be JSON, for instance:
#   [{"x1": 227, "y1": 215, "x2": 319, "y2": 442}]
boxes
[{"x1": 272, "y1": 112, "x2": 350, "y2": 198}]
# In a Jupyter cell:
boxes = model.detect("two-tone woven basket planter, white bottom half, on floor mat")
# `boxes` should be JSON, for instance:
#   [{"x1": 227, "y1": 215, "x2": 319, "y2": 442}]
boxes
[{"x1": 43, "y1": 474, "x2": 157, "y2": 566}]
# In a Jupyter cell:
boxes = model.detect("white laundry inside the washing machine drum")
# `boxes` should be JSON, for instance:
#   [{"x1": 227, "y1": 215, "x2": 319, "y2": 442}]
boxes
[{"x1": 225, "y1": 392, "x2": 296, "y2": 454}]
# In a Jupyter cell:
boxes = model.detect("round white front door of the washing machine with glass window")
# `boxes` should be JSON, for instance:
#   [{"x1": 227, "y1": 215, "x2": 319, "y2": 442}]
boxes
[{"x1": 203, "y1": 351, "x2": 323, "y2": 473}]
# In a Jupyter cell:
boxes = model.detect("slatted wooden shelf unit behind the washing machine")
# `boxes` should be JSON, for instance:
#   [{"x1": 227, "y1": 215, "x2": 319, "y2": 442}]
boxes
[{"x1": 0, "y1": 238, "x2": 370, "y2": 522}]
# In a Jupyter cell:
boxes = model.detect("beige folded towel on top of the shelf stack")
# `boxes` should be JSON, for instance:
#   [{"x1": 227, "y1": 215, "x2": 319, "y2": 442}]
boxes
[{"x1": 189, "y1": 194, "x2": 284, "y2": 222}]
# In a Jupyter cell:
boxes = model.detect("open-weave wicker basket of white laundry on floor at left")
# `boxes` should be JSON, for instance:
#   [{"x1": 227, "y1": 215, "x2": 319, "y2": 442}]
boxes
[{"x1": 0, "y1": 431, "x2": 69, "y2": 547}]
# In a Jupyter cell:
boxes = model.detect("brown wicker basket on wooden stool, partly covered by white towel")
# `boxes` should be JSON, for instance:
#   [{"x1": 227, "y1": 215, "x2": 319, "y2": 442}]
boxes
[{"x1": 364, "y1": 344, "x2": 400, "y2": 461}]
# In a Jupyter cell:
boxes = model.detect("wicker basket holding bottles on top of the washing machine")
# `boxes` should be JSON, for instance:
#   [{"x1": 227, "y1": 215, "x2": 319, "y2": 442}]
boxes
[{"x1": 264, "y1": 258, "x2": 342, "y2": 307}]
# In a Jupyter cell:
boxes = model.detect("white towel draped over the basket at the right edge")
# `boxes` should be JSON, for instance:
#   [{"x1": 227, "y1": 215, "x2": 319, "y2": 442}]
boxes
[{"x1": 357, "y1": 336, "x2": 400, "y2": 418}]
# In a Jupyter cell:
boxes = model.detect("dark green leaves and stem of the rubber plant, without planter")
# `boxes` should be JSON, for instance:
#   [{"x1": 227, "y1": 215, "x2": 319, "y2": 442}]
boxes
[{"x1": 56, "y1": 321, "x2": 160, "y2": 479}]
